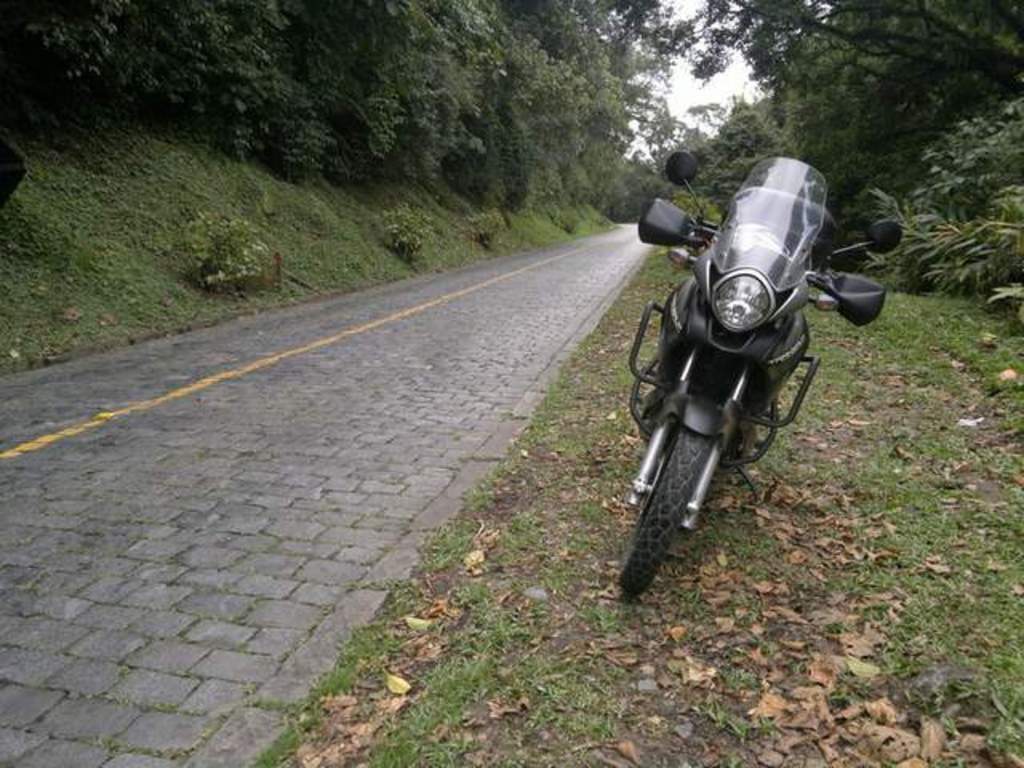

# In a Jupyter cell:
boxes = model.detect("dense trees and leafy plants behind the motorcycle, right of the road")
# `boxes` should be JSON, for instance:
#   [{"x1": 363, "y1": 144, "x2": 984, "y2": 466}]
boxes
[{"x1": 647, "y1": 0, "x2": 1024, "y2": 319}]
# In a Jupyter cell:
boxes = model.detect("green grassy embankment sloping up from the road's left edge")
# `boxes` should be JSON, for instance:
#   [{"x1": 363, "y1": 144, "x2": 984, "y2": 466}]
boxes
[{"x1": 0, "y1": 132, "x2": 606, "y2": 372}]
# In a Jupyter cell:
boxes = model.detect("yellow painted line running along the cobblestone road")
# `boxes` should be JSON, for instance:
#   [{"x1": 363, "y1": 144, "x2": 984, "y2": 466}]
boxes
[{"x1": 0, "y1": 248, "x2": 581, "y2": 460}]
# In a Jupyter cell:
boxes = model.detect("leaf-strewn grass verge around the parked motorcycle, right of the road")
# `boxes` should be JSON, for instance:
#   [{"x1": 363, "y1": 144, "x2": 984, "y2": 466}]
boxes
[{"x1": 260, "y1": 253, "x2": 1024, "y2": 768}]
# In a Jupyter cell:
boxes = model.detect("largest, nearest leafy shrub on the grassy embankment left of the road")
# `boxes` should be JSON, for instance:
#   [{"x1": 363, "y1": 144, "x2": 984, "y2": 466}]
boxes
[{"x1": 184, "y1": 213, "x2": 270, "y2": 292}]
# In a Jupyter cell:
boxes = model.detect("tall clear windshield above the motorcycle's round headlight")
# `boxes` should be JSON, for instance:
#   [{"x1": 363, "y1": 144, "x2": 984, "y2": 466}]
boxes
[{"x1": 712, "y1": 158, "x2": 827, "y2": 291}]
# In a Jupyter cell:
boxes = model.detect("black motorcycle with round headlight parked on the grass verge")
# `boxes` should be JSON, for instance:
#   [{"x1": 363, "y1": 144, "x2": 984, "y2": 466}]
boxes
[{"x1": 620, "y1": 152, "x2": 902, "y2": 596}]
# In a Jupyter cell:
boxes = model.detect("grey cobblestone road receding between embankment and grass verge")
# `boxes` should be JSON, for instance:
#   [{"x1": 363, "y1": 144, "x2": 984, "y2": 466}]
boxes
[{"x1": 0, "y1": 227, "x2": 643, "y2": 768}]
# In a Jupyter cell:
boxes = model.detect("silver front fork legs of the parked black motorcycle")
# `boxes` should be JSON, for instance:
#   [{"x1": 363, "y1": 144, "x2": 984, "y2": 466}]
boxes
[{"x1": 626, "y1": 348, "x2": 750, "y2": 530}]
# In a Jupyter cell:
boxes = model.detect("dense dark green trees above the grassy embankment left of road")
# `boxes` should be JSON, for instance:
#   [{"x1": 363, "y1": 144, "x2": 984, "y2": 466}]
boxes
[{"x1": 0, "y1": 0, "x2": 675, "y2": 208}]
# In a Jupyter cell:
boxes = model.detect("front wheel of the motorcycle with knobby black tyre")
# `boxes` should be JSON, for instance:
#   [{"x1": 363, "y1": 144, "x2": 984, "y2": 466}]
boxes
[{"x1": 618, "y1": 427, "x2": 716, "y2": 597}]
